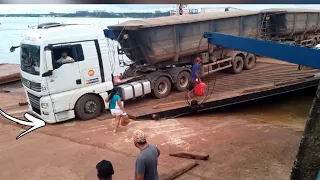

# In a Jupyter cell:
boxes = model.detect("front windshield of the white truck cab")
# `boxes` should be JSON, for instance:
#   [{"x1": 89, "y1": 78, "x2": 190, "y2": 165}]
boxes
[{"x1": 20, "y1": 44, "x2": 40, "y2": 75}]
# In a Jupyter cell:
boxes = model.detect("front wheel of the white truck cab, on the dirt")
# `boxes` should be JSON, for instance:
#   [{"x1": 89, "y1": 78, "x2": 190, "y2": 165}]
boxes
[{"x1": 74, "y1": 94, "x2": 102, "y2": 120}]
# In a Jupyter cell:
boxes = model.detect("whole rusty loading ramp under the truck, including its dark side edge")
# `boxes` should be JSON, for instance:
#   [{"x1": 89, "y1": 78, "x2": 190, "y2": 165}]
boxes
[{"x1": 125, "y1": 57, "x2": 320, "y2": 119}]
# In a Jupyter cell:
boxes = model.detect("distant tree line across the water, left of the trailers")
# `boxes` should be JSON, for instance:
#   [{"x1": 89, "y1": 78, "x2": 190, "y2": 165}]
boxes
[{"x1": 0, "y1": 11, "x2": 170, "y2": 18}]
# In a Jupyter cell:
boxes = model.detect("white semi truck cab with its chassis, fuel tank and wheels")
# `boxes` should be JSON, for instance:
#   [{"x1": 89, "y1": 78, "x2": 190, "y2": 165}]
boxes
[{"x1": 16, "y1": 23, "x2": 255, "y2": 123}]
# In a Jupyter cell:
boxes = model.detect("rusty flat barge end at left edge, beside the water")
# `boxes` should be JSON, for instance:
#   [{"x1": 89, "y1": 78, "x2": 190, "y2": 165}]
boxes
[{"x1": 0, "y1": 64, "x2": 21, "y2": 85}]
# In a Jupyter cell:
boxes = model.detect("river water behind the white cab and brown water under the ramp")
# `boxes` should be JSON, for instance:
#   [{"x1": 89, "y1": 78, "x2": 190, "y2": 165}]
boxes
[{"x1": 0, "y1": 17, "x2": 315, "y2": 129}]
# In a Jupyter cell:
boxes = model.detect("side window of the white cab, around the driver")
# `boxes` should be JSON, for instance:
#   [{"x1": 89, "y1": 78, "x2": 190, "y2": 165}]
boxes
[{"x1": 52, "y1": 44, "x2": 84, "y2": 69}]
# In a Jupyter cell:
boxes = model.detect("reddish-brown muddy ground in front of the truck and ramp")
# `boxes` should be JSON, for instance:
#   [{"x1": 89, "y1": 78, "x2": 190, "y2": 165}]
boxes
[{"x1": 0, "y1": 84, "x2": 303, "y2": 180}]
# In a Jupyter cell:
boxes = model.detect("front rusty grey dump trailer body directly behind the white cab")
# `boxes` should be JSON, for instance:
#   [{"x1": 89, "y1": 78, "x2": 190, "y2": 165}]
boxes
[{"x1": 111, "y1": 12, "x2": 259, "y2": 64}]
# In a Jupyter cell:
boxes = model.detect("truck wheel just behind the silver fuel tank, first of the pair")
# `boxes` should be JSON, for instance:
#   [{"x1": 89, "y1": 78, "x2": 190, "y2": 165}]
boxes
[{"x1": 152, "y1": 76, "x2": 171, "y2": 99}]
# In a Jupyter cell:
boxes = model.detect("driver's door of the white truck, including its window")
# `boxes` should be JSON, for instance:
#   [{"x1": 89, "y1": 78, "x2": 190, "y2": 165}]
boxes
[{"x1": 47, "y1": 43, "x2": 84, "y2": 95}]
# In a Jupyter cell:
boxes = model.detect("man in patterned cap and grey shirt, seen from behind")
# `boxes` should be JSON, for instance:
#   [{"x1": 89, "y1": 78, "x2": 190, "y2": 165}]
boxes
[{"x1": 133, "y1": 130, "x2": 160, "y2": 180}]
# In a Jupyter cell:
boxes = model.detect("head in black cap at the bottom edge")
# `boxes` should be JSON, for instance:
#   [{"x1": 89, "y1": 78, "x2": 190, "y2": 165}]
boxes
[{"x1": 96, "y1": 160, "x2": 114, "y2": 180}]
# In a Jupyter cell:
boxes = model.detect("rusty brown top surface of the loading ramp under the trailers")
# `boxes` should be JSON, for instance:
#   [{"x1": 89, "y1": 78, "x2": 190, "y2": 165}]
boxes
[{"x1": 125, "y1": 61, "x2": 320, "y2": 116}]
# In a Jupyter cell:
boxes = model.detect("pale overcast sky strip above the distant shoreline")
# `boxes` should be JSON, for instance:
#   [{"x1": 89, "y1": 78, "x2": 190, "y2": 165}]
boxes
[{"x1": 0, "y1": 4, "x2": 320, "y2": 14}]
